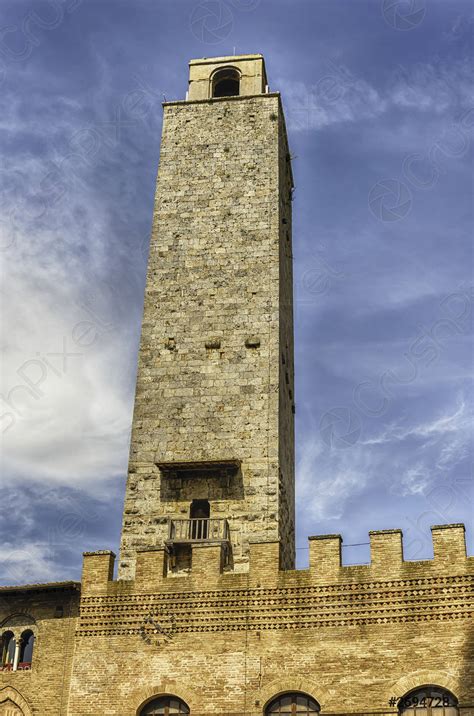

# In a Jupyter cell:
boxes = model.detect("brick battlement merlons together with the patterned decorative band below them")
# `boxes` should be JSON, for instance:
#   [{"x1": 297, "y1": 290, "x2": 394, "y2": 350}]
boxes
[{"x1": 77, "y1": 524, "x2": 474, "y2": 639}]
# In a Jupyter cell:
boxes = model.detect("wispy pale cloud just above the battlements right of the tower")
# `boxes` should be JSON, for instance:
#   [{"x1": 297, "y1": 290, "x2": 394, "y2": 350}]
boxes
[{"x1": 297, "y1": 399, "x2": 473, "y2": 523}]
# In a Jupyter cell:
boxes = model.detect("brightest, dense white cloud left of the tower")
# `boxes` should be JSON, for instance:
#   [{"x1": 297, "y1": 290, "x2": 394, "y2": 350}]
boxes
[{"x1": 1, "y1": 264, "x2": 131, "y2": 489}]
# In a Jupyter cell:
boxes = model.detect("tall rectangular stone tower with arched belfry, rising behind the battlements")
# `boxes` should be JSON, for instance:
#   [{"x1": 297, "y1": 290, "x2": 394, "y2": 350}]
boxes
[{"x1": 119, "y1": 55, "x2": 294, "y2": 579}]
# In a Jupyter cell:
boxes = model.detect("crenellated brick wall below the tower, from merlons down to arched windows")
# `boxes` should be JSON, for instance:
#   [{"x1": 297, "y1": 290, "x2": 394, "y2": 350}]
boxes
[{"x1": 66, "y1": 525, "x2": 474, "y2": 716}]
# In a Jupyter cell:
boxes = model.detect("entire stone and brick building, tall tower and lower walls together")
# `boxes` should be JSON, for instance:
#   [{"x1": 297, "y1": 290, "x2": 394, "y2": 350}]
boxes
[{"x1": 0, "y1": 55, "x2": 474, "y2": 716}]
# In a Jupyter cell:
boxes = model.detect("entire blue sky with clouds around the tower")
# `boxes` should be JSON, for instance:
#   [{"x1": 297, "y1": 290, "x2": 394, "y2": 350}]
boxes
[{"x1": 0, "y1": 0, "x2": 474, "y2": 584}]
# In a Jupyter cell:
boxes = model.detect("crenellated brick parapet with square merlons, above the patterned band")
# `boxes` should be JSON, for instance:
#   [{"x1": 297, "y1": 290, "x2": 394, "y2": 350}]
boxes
[{"x1": 82, "y1": 524, "x2": 474, "y2": 597}]
